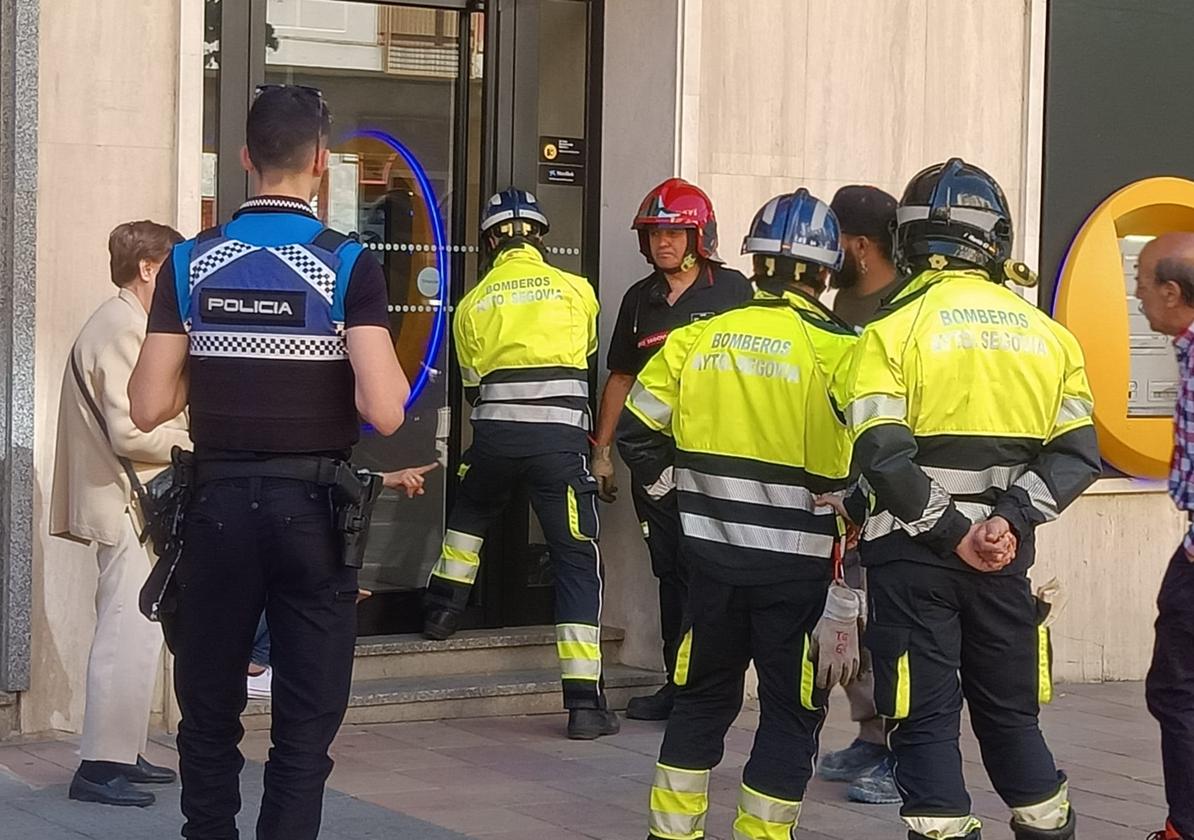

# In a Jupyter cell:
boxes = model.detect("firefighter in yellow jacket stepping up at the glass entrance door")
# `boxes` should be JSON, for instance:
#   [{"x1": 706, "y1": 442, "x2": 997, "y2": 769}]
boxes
[{"x1": 424, "y1": 189, "x2": 618, "y2": 740}]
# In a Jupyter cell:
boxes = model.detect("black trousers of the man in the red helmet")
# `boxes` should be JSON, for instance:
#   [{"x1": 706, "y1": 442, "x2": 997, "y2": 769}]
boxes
[{"x1": 630, "y1": 482, "x2": 688, "y2": 677}]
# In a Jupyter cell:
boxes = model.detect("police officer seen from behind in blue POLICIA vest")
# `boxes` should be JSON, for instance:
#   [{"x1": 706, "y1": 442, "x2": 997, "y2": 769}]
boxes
[{"x1": 129, "y1": 86, "x2": 410, "y2": 840}]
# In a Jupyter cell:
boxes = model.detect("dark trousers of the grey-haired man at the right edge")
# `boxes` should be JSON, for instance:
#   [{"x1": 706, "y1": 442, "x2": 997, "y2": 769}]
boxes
[{"x1": 1145, "y1": 546, "x2": 1194, "y2": 840}]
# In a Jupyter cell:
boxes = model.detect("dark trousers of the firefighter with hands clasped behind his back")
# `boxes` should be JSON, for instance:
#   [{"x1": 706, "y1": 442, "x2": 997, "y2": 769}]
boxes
[{"x1": 867, "y1": 561, "x2": 1073, "y2": 839}]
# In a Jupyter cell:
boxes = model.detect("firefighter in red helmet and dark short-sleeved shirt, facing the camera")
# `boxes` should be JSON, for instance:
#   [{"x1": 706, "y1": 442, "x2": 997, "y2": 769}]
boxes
[{"x1": 593, "y1": 178, "x2": 751, "y2": 721}]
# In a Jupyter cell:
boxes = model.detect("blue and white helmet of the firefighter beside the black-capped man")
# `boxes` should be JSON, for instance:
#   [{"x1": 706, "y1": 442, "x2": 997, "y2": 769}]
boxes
[{"x1": 743, "y1": 187, "x2": 844, "y2": 271}]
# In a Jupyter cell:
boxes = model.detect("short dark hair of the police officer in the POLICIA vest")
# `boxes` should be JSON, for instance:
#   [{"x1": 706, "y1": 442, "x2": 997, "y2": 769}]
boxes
[{"x1": 245, "y1": 85, "x2": 332, "y2": 172}]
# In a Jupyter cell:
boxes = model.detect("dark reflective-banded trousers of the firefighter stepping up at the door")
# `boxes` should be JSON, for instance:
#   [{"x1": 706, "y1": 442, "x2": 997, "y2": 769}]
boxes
[{"x1": 427, "y1": 447, "x2": 605, "y2": 709}]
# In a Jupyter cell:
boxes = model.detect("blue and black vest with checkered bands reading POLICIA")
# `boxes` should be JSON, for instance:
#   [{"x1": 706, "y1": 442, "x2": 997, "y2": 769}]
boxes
[{"x1": 165, "y1": 202, "x2": 362, "y2": 452}]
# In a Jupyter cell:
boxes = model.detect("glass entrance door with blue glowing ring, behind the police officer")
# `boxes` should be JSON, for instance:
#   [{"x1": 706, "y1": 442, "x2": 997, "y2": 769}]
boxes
[{"x1": 203, "y1": 0, "x2": 596, "y2": 635}]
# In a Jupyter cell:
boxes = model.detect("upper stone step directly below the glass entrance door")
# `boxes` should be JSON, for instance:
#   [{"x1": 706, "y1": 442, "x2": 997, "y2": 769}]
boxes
[{"x1": 352, "y1": 625, "x2": 626, "y2": 681}]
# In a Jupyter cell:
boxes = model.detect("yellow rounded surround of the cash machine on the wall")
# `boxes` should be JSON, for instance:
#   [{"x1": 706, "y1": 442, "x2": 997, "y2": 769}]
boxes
[{"x1": 1053, "y1": 178, "x2": 1194, "y2": 478}]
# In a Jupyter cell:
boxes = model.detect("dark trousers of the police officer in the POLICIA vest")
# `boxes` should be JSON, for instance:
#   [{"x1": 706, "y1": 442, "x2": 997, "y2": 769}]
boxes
[{"x1": 174, "y1": 478, "x2": 357, "y2": 840}]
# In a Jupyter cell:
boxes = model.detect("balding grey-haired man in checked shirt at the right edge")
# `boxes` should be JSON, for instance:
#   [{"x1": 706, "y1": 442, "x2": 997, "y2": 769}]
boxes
[{"x1": 1135, "y1": 233, "x2": 1194, "y2": 840}]
